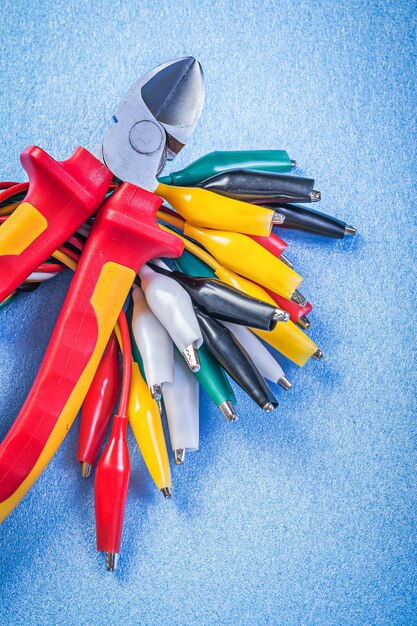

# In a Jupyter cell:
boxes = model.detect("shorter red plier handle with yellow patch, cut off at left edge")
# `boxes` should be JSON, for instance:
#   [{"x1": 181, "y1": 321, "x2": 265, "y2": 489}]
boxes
[{"x1": 0, "y1": 146, "x2": 112, "y2": 302}]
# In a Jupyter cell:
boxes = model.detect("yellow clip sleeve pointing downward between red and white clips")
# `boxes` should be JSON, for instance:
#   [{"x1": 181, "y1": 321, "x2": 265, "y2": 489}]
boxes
[{"x1": 127, "y1": 361, "x2": 171, "y2": 489}]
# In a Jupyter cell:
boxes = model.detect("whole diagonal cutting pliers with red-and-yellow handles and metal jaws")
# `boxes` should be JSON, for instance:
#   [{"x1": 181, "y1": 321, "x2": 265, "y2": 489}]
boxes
[{"x1": 0, "y1": 57, "x2": 204, "y2": 521}]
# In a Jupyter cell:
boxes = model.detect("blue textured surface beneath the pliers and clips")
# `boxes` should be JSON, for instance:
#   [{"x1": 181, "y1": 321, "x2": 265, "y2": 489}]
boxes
[{"x1": 0, "y1": 0, "x2": 417, "y2": 626}]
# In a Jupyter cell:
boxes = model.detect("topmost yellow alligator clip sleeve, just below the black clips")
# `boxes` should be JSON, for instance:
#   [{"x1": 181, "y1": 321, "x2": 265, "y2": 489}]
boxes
[{"x1": 155, "y1": 184, "x2": 274, "y2": 237}]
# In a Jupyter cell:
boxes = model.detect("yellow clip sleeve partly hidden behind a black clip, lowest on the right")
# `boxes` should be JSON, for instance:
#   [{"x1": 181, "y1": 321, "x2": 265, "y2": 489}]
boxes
[{"x1": 216, "y1": 267, "x2": 317, "y2": 366}]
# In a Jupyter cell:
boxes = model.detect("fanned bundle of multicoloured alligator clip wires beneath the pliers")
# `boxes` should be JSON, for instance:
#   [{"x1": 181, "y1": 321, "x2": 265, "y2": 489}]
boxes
[{"x1": 0, "y1": 153, "x2": 356, "y2": 571}]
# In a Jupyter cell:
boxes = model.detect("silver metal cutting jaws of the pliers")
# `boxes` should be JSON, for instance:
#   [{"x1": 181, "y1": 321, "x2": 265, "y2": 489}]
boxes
[{"x1": 98, "y1": 57, "x2": 204, "y2": 191}]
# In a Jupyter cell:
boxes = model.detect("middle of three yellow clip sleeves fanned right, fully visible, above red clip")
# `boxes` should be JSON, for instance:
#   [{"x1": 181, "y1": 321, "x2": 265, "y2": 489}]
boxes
[{"x1": 184, "y1": 222, "x2": 303, "y2": 299}]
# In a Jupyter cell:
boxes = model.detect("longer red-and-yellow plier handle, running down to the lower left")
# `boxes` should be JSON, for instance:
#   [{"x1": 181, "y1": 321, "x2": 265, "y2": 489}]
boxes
[{"x1": 0, "y1": 183, "x2": 183, "y2": 520}]
